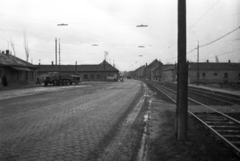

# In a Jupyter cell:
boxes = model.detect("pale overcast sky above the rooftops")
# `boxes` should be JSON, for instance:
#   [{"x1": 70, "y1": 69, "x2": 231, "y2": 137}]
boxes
[{"x1": 0, "y1": 0, "x2": 240, "y2": 71}]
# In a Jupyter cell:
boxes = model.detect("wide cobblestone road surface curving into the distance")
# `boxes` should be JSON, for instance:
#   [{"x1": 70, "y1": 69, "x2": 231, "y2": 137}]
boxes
[{"x1": 0, "y1": 80, "x2": 141, "y2": 161}]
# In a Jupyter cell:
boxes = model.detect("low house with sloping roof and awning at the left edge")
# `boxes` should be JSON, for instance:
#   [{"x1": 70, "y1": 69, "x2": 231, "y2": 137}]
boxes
[{"x1": 0, "y1": 50, "x2": 37, "y2": 86}]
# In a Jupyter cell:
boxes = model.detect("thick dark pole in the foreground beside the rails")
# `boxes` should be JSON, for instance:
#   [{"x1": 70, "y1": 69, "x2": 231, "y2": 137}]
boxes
[{"x1": 175, "y1": 0, "x2": 188, "y2": 141}]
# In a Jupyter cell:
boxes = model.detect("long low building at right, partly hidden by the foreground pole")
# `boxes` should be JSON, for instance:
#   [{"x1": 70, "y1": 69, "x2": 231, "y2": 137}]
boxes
[{"x1": 159, "y1": 61, "x2": 240, "y2": 84}]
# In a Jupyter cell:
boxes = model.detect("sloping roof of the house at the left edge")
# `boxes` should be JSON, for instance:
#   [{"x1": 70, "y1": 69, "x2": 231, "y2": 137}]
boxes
[{"x1": 0, "y1": 53, "x2": 35, "y2": 68}]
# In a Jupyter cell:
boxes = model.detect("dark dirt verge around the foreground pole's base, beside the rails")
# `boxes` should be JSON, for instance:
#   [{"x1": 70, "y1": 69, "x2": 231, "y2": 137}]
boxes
[{"x1": 147, "y1": 99, "x2": 239, "y2": 161}]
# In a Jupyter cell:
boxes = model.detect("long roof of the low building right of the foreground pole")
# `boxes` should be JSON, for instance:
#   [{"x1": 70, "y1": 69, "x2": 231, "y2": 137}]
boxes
[{"x1": 189, "y1": 62, "x2": 240, "y2": 70}]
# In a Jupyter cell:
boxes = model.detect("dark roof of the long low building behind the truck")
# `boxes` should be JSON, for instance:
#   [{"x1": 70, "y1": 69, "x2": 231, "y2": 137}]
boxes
[{"x1": 35, "y1": 62, "x2": 119, "y2": 72}]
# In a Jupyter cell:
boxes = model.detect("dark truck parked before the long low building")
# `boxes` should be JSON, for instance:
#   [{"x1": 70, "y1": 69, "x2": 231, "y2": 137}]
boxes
[{"x1": 44, "y1": 72, "x2": 81, "y2": 86}]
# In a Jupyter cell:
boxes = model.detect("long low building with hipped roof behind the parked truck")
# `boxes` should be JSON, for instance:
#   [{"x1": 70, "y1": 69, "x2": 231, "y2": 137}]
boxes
[{"x1": 35, "y1": 60, "x2": 119, "y2": 81}]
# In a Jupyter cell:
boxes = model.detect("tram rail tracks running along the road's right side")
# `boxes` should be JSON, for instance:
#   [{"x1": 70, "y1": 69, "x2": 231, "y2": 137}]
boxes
[{"x1": 145, "y1": 81, "x2": 240, "y2": 156}]
